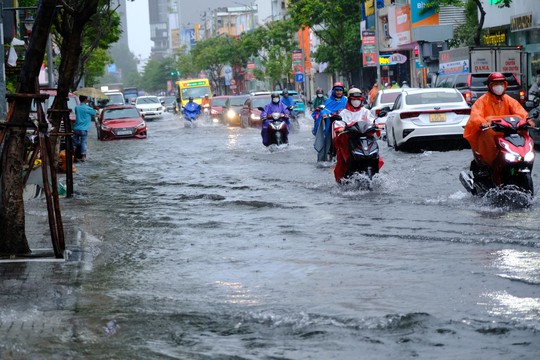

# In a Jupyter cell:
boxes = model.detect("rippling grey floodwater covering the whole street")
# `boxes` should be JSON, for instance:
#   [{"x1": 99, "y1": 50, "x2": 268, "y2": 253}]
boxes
[{"x1": 0, "y1": 115, "x2": 540, "y2": 360}]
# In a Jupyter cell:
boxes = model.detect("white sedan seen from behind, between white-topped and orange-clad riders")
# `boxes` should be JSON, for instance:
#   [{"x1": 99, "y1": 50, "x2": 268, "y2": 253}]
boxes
[{"x1": 381, "y1": 88, "x2": 471, "y2": 151}]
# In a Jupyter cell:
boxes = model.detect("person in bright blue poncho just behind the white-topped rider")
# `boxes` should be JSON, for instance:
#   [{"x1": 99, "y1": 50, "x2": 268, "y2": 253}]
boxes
[{"x1": 313, "y1": 81, "x2": 347, "y2": 161}]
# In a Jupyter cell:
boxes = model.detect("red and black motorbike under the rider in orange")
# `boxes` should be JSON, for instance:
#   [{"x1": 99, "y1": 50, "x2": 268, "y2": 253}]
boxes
[{"x1": 459, "y1": 115, "x2": 535, "y2": 196}]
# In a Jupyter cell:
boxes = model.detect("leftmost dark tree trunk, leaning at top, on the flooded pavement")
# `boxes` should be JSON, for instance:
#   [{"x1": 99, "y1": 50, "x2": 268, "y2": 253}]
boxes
[{"x1": 0, "y1": 0, "x2": 57, "y2": 254}]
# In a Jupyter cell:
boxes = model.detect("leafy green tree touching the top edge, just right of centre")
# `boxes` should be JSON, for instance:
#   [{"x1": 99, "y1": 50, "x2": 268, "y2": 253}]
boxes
[{"x1": 288, "y1": 0, "x2": 362, "y2": 82}]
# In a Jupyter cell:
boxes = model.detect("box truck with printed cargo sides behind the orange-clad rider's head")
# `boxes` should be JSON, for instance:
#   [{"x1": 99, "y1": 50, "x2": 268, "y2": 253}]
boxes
[{"x1": 435, "y1": 46, "x2": 528, "y2": 104}]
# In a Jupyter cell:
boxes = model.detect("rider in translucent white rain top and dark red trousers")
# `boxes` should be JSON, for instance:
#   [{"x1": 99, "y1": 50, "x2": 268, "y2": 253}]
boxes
[{"x1": 333, "y1": 88, "x2": 374, "y2": 182}]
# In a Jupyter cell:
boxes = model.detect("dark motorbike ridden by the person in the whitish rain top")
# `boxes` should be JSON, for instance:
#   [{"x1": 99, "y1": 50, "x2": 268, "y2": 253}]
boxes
[{"x1": 334, "y1": 116, "x2": 383, "y2": 181}]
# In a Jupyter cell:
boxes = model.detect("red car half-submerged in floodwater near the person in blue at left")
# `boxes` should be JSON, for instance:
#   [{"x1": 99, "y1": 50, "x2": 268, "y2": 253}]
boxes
[{"x1": 95, "y1": 105, "x2": 148, "y2": 141}]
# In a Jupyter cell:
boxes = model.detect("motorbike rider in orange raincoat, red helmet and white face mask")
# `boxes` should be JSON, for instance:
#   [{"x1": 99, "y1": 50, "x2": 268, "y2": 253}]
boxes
[{"x1": 463, "y1": 72, "x2": 534, "y2": 180}]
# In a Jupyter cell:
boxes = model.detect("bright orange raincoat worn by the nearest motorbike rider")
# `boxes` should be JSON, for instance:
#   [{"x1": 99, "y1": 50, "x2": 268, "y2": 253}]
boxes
[{"x1": 463, "y1": 92, "x2": 528, "y2": 166}]
